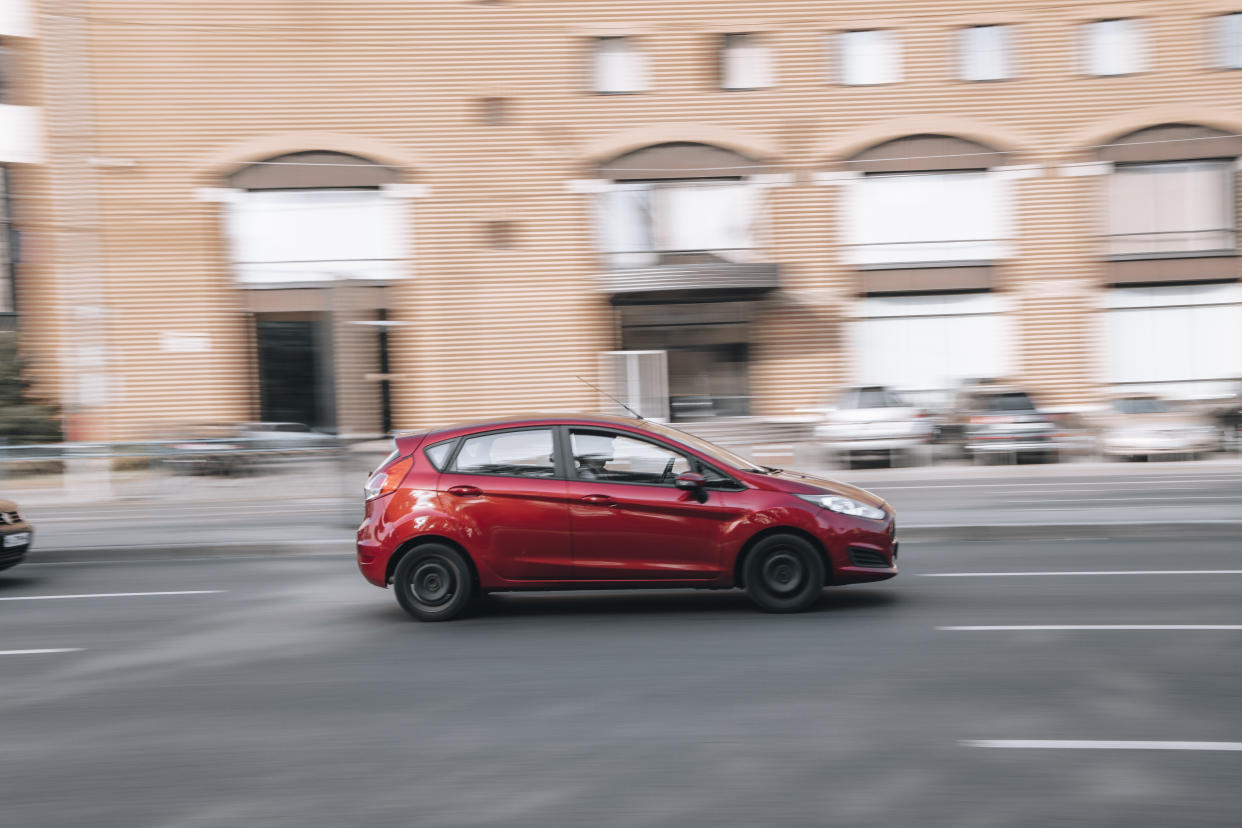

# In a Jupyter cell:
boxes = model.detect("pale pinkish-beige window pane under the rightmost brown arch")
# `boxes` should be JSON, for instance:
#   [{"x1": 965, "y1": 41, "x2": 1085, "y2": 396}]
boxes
[{"x1": 1105, "y1": 161, "x2": 1236, "y2": 258}]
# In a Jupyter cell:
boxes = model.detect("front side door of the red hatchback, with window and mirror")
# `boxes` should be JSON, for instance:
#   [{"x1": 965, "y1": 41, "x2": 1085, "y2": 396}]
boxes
[{"x1": 563, "y1": 427, "x2": 739, "y2": 581}]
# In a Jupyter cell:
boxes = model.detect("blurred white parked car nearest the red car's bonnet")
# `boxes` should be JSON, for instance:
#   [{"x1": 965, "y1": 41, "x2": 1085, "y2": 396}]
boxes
[{"x1": 815, "y1": 385, "x2": 935, "y2": 468}]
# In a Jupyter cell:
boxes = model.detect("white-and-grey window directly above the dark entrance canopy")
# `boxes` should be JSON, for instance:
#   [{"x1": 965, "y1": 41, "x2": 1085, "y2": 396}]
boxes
[{"x1": 596, "y1": 180, "x2": 756, "y2": 267}]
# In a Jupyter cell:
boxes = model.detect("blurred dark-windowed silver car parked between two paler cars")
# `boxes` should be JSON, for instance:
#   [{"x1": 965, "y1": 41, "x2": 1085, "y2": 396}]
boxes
[{"x1": 946, "y1": 384, "x2": 1069, "y2": 463}]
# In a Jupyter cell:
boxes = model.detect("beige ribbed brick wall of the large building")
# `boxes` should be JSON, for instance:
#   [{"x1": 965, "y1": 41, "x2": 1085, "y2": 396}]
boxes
[{"x1": 25, "y1": 0, "x2": 1242, "y2": 436}]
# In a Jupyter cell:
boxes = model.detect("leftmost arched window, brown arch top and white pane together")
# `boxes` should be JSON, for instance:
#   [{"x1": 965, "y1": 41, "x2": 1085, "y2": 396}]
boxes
[{"x1": 227, "y1": 151, "x2": 406, "y2": 284}]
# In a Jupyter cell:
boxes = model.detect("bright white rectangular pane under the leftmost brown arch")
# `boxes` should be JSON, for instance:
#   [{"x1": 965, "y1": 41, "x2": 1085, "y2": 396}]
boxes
[{"x1": 227, "y1": 189, "x2": 405, "y2": 282}]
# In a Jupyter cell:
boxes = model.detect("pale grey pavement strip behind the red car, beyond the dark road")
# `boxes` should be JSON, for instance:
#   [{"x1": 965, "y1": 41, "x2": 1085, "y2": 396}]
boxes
[{"x1": 14, "y1": 459, "x2": 1242, "y2": 560}]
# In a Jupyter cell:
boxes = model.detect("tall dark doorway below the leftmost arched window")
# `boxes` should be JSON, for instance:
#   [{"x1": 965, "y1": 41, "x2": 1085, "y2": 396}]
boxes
[{"x1": 255, "y1": 318, "x2": 330, "y2": 427}]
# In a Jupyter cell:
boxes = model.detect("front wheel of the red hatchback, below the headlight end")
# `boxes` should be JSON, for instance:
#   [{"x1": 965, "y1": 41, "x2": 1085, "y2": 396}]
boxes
[{"x1": 741, "y1": 534, "x2": 825, "y2": 612}]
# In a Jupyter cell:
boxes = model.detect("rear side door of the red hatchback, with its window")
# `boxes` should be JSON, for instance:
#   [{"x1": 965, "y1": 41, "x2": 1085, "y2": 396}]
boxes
[{"x1": 437, "y1": 427, "x2": 573, "y2": 581}]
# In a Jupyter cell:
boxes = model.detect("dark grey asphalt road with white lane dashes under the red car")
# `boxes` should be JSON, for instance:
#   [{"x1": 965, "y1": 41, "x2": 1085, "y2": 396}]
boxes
[{"x1": 0, "y1": 538, "x2": 1242, "y2": 828}]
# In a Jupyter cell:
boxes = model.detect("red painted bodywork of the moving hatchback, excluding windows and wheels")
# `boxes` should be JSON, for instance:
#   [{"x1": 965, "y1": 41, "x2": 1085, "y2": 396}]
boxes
[{"x1": 358, "y1": 415, "x2": 897, "y2": 615}]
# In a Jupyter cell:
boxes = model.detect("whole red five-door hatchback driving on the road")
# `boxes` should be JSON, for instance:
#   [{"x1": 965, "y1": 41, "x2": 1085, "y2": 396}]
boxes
[{"x1": 358, "y1": 415, "x2": 897, "y2": 621}]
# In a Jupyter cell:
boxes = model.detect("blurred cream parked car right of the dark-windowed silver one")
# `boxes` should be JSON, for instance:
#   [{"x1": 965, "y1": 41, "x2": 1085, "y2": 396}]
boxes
[{"x1": 1097, "y1": 395, "x2": 1221, "y2": 459}]
